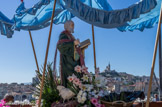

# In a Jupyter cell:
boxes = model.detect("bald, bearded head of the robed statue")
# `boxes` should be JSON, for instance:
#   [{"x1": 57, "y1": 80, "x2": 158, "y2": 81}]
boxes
[{"x1": 64, "y1": 20, "x2": 74, "y2": 33}]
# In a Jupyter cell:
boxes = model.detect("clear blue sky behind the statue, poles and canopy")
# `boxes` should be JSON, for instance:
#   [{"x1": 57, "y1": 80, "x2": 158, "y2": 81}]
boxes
[{"x1": 0, "y1": 0, "x2": 158, "y2": 83}]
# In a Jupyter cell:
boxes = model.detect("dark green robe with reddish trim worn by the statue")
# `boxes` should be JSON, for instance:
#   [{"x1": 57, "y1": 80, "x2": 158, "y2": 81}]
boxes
[{"x1": 57, "y1": 31, "x2": 84, "y2": 87}]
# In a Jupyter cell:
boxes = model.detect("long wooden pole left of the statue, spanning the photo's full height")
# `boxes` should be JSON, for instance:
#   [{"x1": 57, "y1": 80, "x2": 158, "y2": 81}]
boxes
[{"x1": 38, "y1": 0, "x2": 57, "y2": 107}]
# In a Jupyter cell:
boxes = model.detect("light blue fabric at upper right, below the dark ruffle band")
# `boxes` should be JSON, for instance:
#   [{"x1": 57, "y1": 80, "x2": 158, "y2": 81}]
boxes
[{"x1": 118, "y1": 0, "x2": 162, "y2": 31}]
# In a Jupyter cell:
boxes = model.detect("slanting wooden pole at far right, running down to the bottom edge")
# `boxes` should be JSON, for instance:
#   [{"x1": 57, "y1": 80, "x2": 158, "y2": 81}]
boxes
[{"x1": 146, "y1": 2, "x2": 162, "y2": 107}]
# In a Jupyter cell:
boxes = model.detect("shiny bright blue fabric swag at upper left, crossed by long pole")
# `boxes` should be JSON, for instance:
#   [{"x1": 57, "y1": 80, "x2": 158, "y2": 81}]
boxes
[{"x1": 13, "y1": 0, "x2": 73, "y2": 30}]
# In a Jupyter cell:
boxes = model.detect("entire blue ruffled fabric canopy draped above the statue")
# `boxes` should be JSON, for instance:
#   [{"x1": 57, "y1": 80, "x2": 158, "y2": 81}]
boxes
[{"x1": 0, "y1": 0, "x2": 161, "y2": 37}]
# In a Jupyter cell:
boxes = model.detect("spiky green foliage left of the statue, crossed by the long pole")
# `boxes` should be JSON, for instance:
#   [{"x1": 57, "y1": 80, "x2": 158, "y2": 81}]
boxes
[{"x1": 36, "y1": 63, "x2": 60, "y2": 107}]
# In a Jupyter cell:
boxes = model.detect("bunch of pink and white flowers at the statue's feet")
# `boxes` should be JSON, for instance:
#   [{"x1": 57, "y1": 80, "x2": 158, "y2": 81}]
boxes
[{"x1": 64, "y1": 65, "x2": 109, "y2": 107}]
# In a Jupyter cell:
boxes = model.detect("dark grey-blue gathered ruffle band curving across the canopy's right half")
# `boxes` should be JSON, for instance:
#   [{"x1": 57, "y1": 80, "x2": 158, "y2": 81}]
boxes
[{"x1": 64, "y1": 0, "x2": 157, "y2": 28}]
